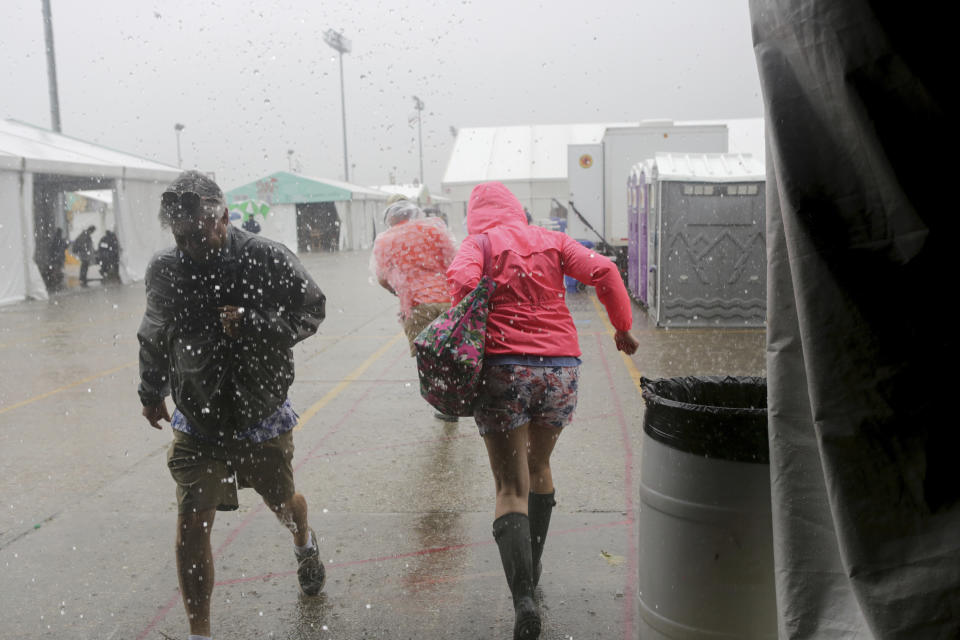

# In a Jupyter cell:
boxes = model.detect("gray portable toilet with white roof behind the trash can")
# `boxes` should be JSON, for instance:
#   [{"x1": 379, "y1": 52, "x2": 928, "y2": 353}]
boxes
[{"x1": 647, "y1": 153, "x2": 767, "y2": 327}]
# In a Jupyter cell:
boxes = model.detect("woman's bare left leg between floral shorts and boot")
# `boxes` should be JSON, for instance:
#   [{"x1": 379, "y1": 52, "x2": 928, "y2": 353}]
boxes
[{"x1": 483, "y1": 425, "x2": 530, "y2": 518}]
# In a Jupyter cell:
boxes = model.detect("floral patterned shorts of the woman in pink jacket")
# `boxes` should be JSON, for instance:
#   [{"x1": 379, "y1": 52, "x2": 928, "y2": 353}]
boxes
[{"x1": 473, "y1": 364, "x2": 580, "y2": 436}]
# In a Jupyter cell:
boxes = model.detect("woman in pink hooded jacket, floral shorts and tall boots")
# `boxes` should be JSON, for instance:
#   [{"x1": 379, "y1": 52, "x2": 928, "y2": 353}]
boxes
[{"x1": 447, "y1": 182, "x2": 638, "y2": 639}]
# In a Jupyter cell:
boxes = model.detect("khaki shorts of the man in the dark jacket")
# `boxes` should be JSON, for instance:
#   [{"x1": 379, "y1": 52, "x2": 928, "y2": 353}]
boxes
[{"x1": 167, "y1": 430, "x2": 294, "y2": 515}]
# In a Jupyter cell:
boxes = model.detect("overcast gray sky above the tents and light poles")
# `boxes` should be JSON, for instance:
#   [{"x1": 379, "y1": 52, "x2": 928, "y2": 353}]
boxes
[{"x1": 0, "y1": 0, "x2": 762, "y2": 192}]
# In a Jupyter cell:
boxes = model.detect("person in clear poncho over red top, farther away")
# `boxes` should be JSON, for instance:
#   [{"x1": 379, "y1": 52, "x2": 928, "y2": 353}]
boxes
[{"x1": 370, "y1": 198, "x2": 457, "y2": 422}]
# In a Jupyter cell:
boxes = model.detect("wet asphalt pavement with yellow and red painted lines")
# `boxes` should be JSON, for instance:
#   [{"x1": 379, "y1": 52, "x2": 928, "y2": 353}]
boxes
[{"x1": 0, "y1": 252, "x2": 764, "y2": 640}]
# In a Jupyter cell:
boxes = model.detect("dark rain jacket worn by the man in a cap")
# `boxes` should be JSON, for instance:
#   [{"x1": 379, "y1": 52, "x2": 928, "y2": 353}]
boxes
[{"x1": 137, "y1": 225, "x2": 326, "y2": 439}]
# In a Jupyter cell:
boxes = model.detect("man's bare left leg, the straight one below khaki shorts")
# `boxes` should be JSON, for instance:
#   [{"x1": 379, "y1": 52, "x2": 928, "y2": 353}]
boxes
[{"x1": 176, "y1": 509, "x2": 217, "y2": 636}]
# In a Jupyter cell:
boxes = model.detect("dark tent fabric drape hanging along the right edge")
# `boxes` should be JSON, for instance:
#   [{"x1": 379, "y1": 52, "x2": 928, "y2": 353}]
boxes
[{"x1": 751, "y1": 0, "x2": 960, "y2": 638}]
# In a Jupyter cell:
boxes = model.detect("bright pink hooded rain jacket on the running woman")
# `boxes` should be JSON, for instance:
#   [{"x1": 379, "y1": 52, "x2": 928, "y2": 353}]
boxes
[{"x1": 447, "y1": 182, "x2": 633, "y2": 356}]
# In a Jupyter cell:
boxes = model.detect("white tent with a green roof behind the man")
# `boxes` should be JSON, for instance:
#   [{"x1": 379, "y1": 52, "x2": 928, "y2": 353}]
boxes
[{"x1": 226, "y1": 171, "x2": 390, "y2": 251}]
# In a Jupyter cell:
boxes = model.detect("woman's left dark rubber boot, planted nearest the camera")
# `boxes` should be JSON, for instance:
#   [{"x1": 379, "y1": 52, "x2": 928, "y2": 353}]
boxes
[{"x1": 493, "y1": 513, "x2": 540, "y2": 640}]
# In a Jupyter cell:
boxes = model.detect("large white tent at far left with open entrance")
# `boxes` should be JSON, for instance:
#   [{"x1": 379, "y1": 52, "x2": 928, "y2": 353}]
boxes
[{"x1": 0, "y1": 120, "x2": 179, "y2": 304}]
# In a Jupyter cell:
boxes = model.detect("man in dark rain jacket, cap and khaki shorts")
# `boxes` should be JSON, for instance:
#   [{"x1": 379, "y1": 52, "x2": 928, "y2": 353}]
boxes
[{"x1": 137, "y1": 171, "x2": 325, "y2": 638}]
